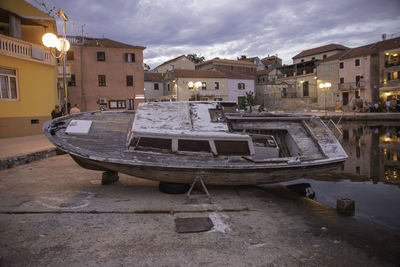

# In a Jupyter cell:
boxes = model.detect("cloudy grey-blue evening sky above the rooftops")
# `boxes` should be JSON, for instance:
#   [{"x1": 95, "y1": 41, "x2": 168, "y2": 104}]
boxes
[{"x1": 28, "y1": 0, "x2": 400, "y2": 68}]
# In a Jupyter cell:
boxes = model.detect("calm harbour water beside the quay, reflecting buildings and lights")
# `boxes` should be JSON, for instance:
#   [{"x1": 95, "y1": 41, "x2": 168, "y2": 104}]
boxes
[{"x1": 285, "y1": 122, "x2": 400, "y2": 233}]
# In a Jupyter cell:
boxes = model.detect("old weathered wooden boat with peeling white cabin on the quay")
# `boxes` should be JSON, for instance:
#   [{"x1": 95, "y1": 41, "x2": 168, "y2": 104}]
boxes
[{"x1": 43, "y1": 101, "x2": 347, "y2": 185}]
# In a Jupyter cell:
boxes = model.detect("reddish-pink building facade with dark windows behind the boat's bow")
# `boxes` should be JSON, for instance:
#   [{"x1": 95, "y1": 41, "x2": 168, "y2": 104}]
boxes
[{"x1": 67, "y1": 36, "x2": 145, "y2": 111}]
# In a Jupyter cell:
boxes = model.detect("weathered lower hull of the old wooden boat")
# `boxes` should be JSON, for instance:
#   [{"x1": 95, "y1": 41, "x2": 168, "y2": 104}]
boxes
[{"x1": 71, "y1": 155, "x2": 343, "y2": 185}]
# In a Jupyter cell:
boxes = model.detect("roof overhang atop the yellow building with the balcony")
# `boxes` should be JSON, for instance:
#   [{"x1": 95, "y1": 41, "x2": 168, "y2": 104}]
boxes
[{"x1": 0, "y1": 0, "x2": 54, "y2": 20}]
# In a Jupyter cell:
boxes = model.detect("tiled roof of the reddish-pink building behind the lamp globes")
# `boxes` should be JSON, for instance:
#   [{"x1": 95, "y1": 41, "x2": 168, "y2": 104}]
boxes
[{"x1": 67, "y1": 36, "x2": 146, "y2": 50}]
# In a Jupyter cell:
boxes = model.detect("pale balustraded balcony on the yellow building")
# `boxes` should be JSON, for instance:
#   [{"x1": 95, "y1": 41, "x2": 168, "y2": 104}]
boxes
[{"x1": 0, "y1": 34, "x2": 56, "y2": 66}]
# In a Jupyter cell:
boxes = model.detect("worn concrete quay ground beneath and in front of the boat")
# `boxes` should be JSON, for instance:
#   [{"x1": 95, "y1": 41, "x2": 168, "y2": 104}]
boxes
[{"x1": 0, "y1": 155, "x2": 400, "y2": 266}]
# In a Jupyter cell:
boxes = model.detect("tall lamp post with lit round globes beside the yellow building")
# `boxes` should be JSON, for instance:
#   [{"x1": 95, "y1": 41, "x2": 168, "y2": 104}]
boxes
[{"x1": 42, "y1": 10, "x2": 70, "y2": 114}]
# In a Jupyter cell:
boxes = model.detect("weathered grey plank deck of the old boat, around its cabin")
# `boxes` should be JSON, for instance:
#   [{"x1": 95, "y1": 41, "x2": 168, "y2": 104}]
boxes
[{"x1": 48, "y1": 111, "x2": 343, "y2": 168}]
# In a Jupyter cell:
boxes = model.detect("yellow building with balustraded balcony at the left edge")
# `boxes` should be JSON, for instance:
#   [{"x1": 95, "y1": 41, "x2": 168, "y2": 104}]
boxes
[{"x1": 0, "y1": 0, "x2": 57, "y2": 138}]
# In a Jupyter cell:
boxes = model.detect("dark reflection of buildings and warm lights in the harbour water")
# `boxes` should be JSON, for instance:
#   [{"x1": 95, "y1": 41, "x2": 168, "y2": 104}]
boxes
[{"x1": 341, "y1": 122, "x2": 400, "y2": 185}]
